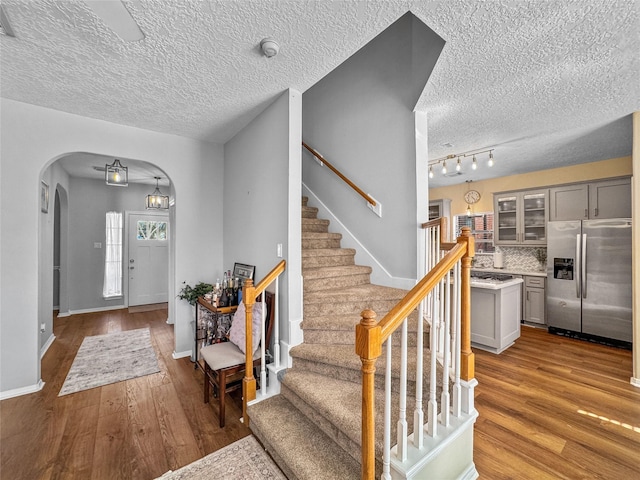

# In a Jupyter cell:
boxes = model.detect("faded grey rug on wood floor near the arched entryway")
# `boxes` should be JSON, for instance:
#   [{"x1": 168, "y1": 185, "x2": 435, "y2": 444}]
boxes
[{"x1": 58, "y1": 328, "x2": 160, "y2": 396}]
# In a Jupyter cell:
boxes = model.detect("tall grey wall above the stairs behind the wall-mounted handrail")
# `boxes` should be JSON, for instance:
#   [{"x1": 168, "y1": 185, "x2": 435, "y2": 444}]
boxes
[{"x1": 302, "y1": 13, "x2": 444, "y2": 279}]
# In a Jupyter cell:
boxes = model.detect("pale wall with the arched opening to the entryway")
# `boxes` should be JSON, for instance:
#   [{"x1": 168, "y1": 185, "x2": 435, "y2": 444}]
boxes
[{"x1": 0, "y1": 99, "x2": 224, "y2": 396}]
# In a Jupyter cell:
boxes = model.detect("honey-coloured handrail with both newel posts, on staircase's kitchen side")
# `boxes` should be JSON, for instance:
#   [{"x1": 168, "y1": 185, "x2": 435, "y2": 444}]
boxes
[{"x1": 356, "y1": 227, "x2": 475, "y2": 480}]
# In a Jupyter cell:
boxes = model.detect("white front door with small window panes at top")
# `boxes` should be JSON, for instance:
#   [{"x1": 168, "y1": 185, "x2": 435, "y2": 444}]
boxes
[{"x1": 127, "y1": 213, "x2": 169, "y2": 307}]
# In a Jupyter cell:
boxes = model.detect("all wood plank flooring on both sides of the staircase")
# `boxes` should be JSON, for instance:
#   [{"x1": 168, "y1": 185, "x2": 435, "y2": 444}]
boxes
[{"x1": 0, "y1": 310, "x2": 640, "y2": 480}]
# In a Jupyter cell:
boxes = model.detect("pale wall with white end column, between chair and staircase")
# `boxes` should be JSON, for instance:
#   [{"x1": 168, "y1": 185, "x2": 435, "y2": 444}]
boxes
[{"x1": 224, "y1": 90, "x2": 302, "y2": 360}]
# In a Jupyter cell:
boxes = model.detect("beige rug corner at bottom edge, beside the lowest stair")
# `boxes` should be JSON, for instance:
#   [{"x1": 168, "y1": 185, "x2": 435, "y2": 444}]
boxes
[{"x1": 157, "y1": 435, "x2": 287, "y2": 480}]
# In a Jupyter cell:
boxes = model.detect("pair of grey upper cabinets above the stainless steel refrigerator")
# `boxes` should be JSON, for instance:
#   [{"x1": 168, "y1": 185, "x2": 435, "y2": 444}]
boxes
[{"x1": 549, "y1": 177, "x2": 631, "y2": 221}]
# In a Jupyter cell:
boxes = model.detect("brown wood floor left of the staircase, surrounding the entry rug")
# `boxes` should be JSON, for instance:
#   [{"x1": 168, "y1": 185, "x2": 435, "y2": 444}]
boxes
[{"x1": 0, "y1": 310, "x2": 249, "y2": 480}]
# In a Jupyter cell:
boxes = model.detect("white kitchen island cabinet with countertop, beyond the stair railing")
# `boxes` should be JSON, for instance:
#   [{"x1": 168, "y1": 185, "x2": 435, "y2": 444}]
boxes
[{"x1": 471, "y1": 272, "x2": 522, "y2": 353}]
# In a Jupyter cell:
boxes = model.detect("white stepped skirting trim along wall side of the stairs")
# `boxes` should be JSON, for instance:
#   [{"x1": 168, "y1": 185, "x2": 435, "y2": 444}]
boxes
[{"x1": 302, "y1": 182, "x2": 416, "y2": 290}]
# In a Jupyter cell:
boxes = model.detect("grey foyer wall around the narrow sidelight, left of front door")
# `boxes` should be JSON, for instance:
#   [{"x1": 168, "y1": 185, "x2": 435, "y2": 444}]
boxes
[{"x1": 68, "y1": 177, "x2": 158, "y2": 312}]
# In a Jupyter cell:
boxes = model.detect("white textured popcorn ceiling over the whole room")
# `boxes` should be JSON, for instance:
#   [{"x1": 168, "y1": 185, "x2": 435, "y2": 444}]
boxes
[{"x1": 0, "y1": 0, "x2": 640, "y2": 186}]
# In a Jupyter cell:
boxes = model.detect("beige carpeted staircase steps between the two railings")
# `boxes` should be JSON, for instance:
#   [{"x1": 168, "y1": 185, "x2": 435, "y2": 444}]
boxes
[{"x1": 248, "y1": 197, "x2": 436, "y2": 480}]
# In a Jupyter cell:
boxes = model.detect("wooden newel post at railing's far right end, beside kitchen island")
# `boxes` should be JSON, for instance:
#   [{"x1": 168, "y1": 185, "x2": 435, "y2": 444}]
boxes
[{"x1": 458, "y1": 227, "x2": 476, "y2": 382}]
